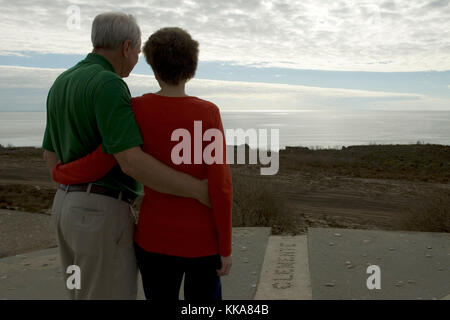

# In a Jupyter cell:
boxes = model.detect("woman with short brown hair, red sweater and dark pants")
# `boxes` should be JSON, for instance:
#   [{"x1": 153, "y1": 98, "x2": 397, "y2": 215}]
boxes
[{"x1": 53, "y1": 28, "x2": 232, "y2": 301}]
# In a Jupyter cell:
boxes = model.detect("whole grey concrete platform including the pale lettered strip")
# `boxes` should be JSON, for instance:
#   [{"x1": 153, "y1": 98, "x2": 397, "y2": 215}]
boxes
[{"x1": 0, "y1": 228, "x2": 450, "y2": 300}]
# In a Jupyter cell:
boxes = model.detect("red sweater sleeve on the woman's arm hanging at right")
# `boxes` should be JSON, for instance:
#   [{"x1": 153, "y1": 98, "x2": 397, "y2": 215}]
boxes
[{"x1": 208, "y1": 107, "x2": 233, "y2": 257}]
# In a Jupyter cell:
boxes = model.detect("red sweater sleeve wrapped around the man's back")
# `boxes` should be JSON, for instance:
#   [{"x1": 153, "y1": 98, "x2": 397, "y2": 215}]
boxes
[{"x1": 52, "y1": 145, "x2": 117, "y2": 184}]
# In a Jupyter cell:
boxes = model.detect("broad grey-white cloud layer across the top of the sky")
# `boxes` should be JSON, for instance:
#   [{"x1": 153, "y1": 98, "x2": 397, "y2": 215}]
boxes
[{"x1": 0, "y1": 0, "x2": 450, "y2": 71}]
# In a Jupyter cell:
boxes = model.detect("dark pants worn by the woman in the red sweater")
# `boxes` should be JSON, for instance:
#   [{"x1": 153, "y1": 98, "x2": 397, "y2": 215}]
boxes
[{"x1": 134, "y1": 243, "x2": 222, "y2": 301}]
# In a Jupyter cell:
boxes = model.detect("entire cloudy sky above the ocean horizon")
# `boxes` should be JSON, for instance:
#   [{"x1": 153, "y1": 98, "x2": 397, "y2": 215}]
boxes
[{"x1": 0, "y1": 0, "x2": 450, "y2": 111}]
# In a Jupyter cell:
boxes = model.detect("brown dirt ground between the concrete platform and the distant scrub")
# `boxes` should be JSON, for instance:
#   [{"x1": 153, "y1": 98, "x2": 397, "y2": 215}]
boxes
[{"x1": 0, "y1": 148, "x2": 450, "y2": 257}]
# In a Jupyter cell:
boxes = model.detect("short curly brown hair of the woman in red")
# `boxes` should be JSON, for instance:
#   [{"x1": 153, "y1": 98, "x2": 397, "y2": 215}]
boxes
[{"x1": 142, "y1": 27, "x2": 198, "y2": 85}]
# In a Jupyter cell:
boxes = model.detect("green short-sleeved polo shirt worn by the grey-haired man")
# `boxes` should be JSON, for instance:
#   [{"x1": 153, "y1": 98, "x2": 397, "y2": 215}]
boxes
[{"x1": 42, "y1": 53, "x2": 143, "y2": 195}]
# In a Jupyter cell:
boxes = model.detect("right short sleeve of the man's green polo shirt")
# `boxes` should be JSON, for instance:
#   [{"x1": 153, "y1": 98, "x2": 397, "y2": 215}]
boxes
[{"x1": 95, "y1": 79, "x2": 143, "y2": 154}]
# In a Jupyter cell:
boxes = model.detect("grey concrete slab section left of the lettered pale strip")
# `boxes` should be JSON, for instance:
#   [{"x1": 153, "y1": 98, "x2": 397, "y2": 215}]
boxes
[{"x1": 0, "y1": 228, "x2": 270, "y2": 300}]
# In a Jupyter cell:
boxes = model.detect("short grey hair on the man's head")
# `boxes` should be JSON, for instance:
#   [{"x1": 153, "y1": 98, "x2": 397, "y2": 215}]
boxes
[{"x1": 91, "y1": 12, "x2": 141, "y2": 49}]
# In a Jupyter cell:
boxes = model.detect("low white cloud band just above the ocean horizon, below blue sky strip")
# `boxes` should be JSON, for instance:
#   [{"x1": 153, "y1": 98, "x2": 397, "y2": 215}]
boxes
[{"x1": 0, "y1": 66, "x2": 450, "y2": 111}]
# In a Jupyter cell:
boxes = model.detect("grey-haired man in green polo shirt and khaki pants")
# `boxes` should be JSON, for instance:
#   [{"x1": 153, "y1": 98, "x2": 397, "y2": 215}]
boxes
[{"x1": 43, "y1": 13, "x2": 209, "y2": 299}]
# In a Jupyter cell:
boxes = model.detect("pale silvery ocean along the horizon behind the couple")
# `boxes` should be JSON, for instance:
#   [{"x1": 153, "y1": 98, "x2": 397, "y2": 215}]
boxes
[{"x1": 0, "y1": 110, "x2": 450, "y2": 148}]
